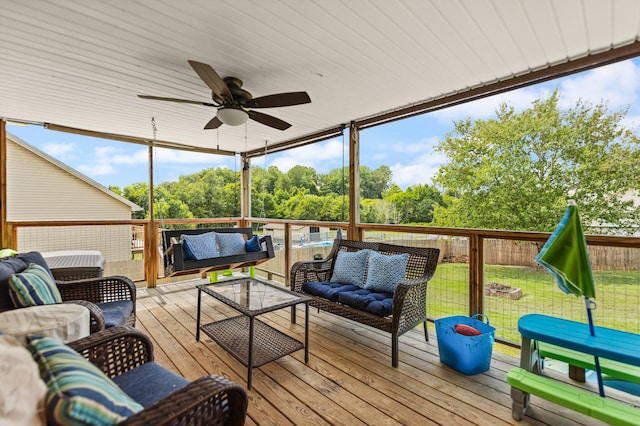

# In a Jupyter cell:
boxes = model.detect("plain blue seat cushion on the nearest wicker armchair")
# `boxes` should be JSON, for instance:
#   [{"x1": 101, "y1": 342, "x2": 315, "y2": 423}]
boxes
[{"x1": 113, "y1": 361, "x2": 189, "y2": 407}]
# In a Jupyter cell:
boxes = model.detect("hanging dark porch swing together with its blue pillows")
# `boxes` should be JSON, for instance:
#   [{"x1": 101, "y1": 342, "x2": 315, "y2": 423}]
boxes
[{"x1": 154, "y1": 124, "x2": 275, "y2": 278}]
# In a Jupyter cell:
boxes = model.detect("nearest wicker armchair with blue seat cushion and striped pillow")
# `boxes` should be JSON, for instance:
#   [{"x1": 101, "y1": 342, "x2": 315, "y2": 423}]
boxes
[{"x1": 30, "y1": 327, "x2": 248, "y2": 426}]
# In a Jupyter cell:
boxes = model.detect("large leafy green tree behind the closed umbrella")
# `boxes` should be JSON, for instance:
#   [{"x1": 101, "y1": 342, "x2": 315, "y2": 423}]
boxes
[{"x1": 434, "y1": 91, "x2": 640, "y2": 231}]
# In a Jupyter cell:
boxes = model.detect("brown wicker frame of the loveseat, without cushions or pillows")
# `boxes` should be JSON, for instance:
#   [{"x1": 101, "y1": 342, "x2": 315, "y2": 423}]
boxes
[{"x1": 291, "y1": 239, "x2": 440, "y2": 367}]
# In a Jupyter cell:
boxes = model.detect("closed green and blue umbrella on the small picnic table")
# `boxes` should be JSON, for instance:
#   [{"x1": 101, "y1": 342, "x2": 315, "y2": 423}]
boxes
[{"x1": 536, "y1": 200, "x2": 604, "y2": 397}]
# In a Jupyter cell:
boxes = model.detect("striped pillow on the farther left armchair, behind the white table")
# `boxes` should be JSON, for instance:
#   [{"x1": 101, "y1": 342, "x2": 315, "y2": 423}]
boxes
[{"x1": 9, "y1": 263, "x2": 62, "y2": 308}]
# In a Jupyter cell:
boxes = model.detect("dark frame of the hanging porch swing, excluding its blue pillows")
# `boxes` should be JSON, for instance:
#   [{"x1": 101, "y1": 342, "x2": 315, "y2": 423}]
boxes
[{"x1": 162, "y1": 228, "x2": 275, "y2": 276}]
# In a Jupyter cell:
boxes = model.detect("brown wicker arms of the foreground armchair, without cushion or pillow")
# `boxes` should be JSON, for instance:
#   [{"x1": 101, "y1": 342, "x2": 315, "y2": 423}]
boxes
[{"x1": 68, "y1": 327, "x2": 248, "y2": 426}]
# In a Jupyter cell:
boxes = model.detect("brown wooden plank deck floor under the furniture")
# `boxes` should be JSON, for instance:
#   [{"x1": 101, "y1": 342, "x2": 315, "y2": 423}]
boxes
[{"x1": 136, "y1": 281, "x2": 602, "y2": 426}]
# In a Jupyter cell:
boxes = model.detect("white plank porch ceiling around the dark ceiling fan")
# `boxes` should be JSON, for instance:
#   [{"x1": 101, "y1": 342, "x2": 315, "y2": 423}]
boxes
[{"x1": 0, "y1": 0, "x2": 640, "y2": 157}]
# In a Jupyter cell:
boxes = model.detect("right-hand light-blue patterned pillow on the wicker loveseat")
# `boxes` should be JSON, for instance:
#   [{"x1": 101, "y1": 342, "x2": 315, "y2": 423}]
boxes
[{"x1": 364, "y1": 251, "x2": 409, "y2": 293}]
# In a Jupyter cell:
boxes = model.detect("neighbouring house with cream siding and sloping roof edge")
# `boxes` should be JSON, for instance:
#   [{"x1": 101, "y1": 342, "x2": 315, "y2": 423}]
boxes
[{"x1": 7, "y1": 133, "x2": 142, "y2": 262}]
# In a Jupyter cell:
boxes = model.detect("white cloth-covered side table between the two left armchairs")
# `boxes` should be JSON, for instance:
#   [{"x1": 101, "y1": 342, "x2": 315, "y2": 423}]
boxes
[{"x1": 0, "y1": 303, "x2": 90, "y2": 343}]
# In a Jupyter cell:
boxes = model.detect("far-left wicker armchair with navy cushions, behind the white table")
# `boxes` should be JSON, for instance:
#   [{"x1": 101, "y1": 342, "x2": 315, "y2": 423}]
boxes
[{"x1": 0, "y1": 251, "x2": 136, "y2": 333}]
